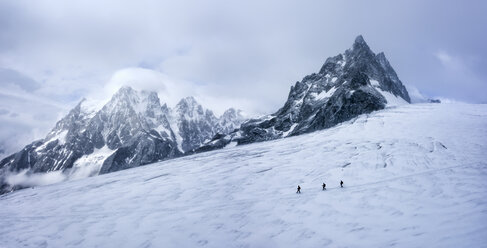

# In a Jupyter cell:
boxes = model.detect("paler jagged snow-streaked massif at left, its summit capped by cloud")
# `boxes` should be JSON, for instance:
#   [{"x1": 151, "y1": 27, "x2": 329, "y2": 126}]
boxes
[{"x1": 0, "y1": 87, "x2": 243, "y2": 192}]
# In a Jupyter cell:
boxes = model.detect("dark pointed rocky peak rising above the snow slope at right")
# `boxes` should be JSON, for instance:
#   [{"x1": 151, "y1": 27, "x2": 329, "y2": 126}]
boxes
[{"x1": 197, "y1": 36, "x2": 410, "y2": 151}]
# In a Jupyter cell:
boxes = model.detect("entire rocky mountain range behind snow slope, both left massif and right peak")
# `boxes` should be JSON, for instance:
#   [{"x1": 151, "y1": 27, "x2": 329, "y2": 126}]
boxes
[{"x1": 0, "y1": 36, "x2": 411, "y2": 192}]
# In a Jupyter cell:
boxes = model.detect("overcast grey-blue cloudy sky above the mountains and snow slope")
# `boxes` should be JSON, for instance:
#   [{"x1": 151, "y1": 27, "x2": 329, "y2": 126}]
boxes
[{"x1": 0, "y1": 0, "x2": 487, "y2": 153}]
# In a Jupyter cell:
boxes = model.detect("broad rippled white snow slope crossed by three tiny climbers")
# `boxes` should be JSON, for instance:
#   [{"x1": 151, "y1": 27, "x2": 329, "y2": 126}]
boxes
[{"x1": 0, "y1": 104, "x2": 487, "y2": 247}]
